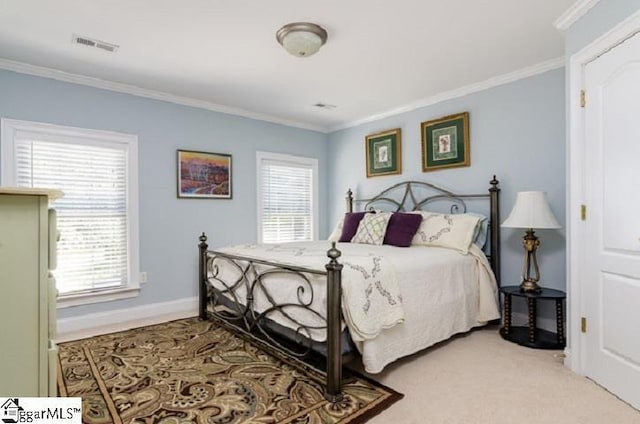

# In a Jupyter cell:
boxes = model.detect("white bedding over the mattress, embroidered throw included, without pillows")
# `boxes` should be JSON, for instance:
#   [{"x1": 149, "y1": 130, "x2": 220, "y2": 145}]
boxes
[{"x1": 212, "y1": 241, "x2": 500, "y2": 373}]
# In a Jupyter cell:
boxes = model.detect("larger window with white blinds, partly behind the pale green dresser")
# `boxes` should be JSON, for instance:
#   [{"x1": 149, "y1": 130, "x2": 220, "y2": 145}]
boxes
[{"x1": 2, "y1": 119, "x2": 139, "y2": 306}]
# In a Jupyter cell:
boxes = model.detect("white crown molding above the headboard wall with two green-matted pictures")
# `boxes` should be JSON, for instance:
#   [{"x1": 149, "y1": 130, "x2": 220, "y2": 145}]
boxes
[{"x1": 329, "y1": 57, "x2": 565, "y2": 133}]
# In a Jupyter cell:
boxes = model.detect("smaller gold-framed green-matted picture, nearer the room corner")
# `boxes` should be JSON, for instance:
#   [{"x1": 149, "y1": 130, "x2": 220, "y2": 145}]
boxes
[{"x1": 365, "y1": 128, "x2": 402, "y2": 178}]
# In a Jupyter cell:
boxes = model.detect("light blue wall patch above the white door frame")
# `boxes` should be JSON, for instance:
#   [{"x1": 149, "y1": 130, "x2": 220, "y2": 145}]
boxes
[{"x1": 565, "y1": 0, "x2": 640, "y2": 57}]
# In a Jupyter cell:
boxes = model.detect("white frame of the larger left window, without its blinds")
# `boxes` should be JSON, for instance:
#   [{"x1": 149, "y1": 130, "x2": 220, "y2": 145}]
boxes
[{"x1": 0, "y1": 118, "x2": 140, "y2": 308}]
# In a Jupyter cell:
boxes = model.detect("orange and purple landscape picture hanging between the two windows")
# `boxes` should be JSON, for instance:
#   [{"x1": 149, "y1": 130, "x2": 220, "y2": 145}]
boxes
[{"x1": 178, "y1": 150, "x2": 231, "y2": 199}]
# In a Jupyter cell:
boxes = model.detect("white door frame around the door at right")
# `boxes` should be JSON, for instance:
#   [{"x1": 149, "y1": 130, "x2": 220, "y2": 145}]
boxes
[{"x1": 564, "y1": 10, "x2": 640, "y2": 375}]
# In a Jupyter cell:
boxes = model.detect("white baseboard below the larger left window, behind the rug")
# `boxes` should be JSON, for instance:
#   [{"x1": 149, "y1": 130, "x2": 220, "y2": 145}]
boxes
[{"x1": 55, "y1": 297, "x2": 198, "y2": 343}]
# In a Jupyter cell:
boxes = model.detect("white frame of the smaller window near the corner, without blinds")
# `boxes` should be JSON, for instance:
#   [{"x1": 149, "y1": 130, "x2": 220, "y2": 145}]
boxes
[{"x1": 256, "y1": 151, "x2": 319, "y2": 243}]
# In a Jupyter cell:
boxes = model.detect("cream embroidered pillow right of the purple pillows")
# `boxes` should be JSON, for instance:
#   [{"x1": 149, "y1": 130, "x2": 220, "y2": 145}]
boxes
[{"x1": 411, "y1": 212, "x2": 480, "y2": 254}]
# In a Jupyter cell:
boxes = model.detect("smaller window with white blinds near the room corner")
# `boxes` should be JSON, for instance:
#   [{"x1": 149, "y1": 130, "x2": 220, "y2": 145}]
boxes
[{"x1": 257, "y1": 152, "x2": 318, "y2": 243}]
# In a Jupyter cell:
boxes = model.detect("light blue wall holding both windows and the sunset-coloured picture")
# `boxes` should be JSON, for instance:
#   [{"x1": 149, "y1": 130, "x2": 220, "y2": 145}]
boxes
[{"x1": 0, "y1": 71, "x2": 327, "y2": 318}]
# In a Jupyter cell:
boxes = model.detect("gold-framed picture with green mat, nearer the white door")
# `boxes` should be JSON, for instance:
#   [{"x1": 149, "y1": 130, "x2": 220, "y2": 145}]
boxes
[{"x1": 420, "y1": 112, "x2": 471, "y2": 172}]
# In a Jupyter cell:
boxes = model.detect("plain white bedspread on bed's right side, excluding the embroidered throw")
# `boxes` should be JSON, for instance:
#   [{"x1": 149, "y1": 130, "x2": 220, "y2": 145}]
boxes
[{"x1": 357, "y1": 245, "x2": 500, "y2": 374}]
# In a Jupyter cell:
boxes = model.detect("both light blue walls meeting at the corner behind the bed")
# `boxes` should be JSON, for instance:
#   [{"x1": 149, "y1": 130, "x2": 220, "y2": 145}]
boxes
[{"x1": 0, "y1": 64, "x2": 565, "y2": 318}]
